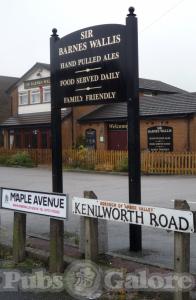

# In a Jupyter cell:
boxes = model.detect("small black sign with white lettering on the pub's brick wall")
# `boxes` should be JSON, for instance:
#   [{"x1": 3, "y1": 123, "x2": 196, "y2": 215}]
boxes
[{"x1": 147, "y1": 126, "x2": 173, "y2": 151}]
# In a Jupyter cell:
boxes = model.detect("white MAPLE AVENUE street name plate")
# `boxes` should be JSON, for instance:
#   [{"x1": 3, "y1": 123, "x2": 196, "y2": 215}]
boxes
[{"x1": 1, "y1": 188, "x2": 68, "y2": 219}]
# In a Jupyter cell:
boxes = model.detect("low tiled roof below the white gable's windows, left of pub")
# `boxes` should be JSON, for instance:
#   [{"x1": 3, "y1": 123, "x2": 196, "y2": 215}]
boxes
[{"x1": 0, "y1": 108, "x2": 71, "y2": 127}]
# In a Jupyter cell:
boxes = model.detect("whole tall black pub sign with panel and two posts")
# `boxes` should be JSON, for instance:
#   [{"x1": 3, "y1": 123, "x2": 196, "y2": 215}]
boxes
[{"x1": 50, "y1": 7, "x2": 142, "y2": 271}]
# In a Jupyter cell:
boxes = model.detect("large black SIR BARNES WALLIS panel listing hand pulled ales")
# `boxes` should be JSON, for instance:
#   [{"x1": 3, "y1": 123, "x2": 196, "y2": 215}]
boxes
[{"x1": 52, "y1": 24, "x2": 126, "y2": 108}]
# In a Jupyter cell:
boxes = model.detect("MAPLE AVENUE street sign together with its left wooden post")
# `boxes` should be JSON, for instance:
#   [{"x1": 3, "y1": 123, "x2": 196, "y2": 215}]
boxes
[{"x1": 0, "y1": 188, "x2": 68, "y2": 263}]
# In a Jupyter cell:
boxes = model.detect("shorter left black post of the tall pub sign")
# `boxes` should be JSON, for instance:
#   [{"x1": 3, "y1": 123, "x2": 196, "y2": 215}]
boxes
[{"x1": 50, "y1": 29, "x2": 64, "y2": 273}]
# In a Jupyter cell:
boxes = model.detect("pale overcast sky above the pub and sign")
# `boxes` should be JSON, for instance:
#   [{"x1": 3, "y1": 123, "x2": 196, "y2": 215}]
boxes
[{"x1": 0, "y1": 0, "x2": 196, "y2": 92}]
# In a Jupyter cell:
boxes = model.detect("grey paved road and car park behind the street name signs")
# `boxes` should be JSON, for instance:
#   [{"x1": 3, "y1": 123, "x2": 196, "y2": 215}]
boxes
[{"x1": 0, "y1": 167, "x2": 196, "y2": 273}]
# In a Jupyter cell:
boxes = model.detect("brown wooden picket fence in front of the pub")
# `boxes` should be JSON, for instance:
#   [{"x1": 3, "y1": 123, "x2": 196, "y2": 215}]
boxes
[{"x1": 0, "y1": 148, "x2": 196, "y2": 175}]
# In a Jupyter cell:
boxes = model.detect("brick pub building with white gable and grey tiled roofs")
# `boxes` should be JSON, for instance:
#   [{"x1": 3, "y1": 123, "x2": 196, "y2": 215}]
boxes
[{"x1": 0, "y1": 63, "x2": 196, "y2": 151}]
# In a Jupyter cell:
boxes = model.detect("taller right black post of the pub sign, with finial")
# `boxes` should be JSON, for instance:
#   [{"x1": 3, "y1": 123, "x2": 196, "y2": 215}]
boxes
[{"x1": 126, "y1": 7, "x2": 142, "y2": 251}]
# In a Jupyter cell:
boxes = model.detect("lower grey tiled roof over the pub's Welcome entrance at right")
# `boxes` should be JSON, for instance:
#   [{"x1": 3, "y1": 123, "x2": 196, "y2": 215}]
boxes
[{"x1": 79, "y1": 93, "x2": 196, "y2": 122}]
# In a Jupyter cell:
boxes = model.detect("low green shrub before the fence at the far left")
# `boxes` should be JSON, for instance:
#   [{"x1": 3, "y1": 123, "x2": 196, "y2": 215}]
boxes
[{"x1": 0, "y1": 152, "x2": 35, "y2": 168}]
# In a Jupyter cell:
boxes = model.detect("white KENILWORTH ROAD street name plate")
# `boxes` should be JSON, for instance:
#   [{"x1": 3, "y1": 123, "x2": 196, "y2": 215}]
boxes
[{"x1": 72, "y1": 197, "x2": 194, "y2": 233}]
